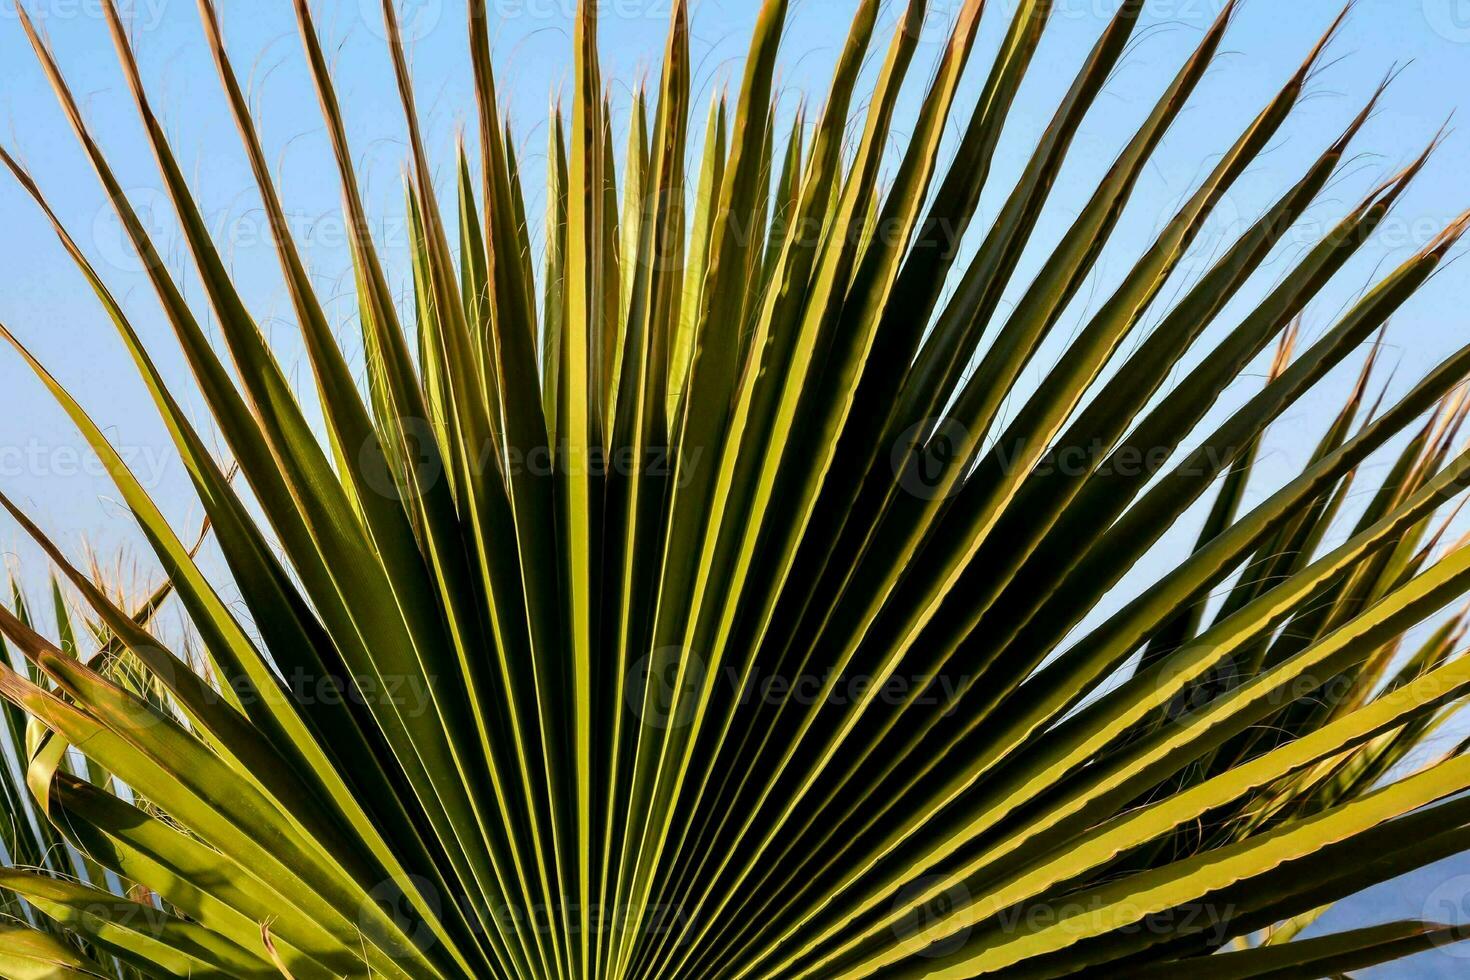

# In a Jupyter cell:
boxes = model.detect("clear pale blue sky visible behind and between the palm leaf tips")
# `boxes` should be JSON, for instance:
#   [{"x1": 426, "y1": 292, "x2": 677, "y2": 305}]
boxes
[{"x1": 0, "y1": 0, "x2": 1470, "y2": 977}]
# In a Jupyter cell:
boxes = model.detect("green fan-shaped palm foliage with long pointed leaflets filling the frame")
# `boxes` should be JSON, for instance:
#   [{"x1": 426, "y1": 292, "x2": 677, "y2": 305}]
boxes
[{"x1": 0, "y1": 0, "x2": 1470, "y2": 980}]
